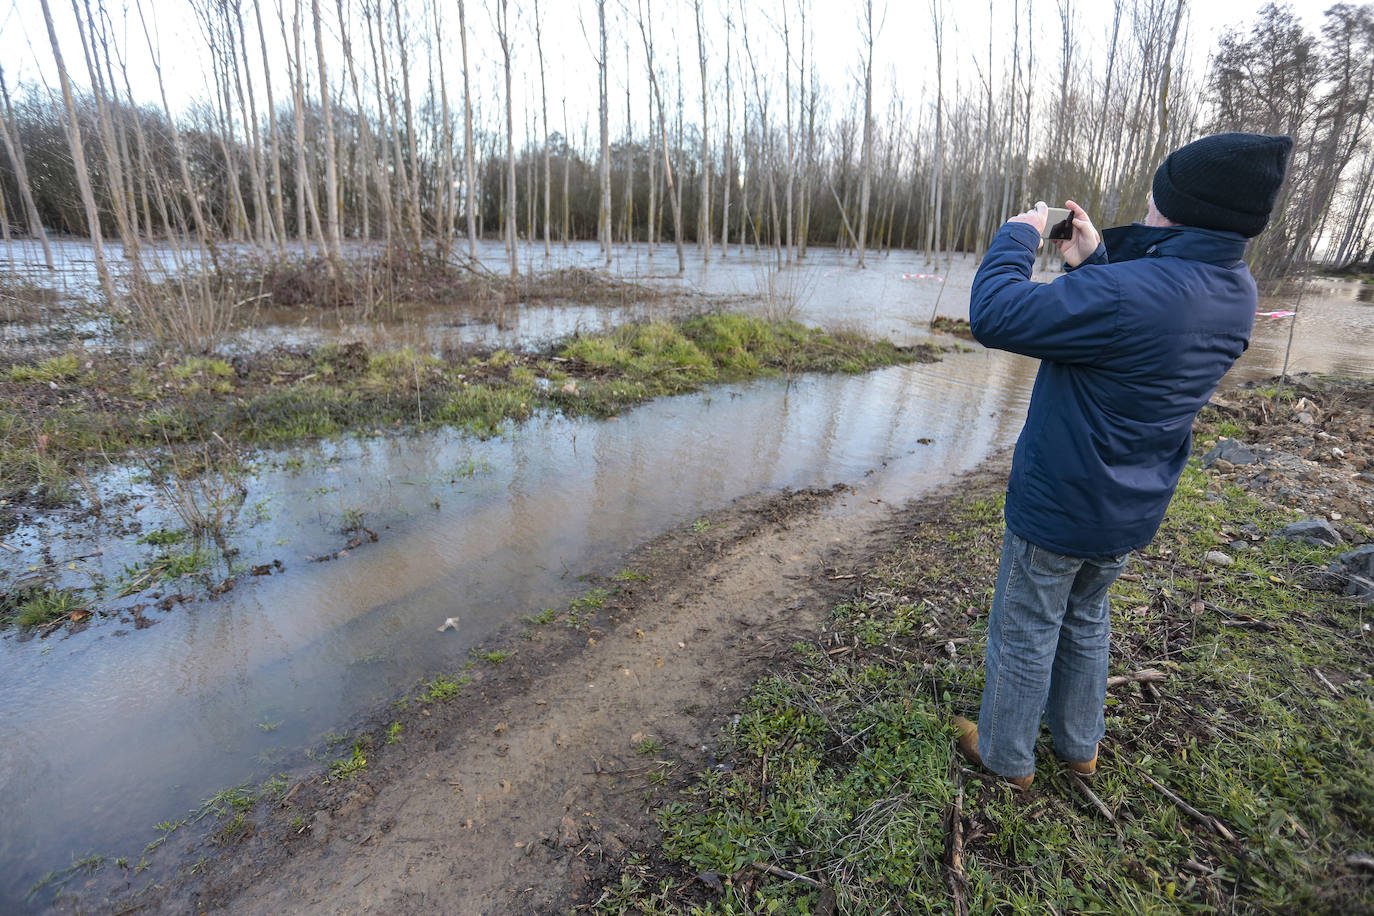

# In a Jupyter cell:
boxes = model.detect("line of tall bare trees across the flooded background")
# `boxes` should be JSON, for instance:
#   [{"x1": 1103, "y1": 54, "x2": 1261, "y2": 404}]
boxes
[{"x1": 0, "y1": 0, "x2": 1374, "y2": 295}]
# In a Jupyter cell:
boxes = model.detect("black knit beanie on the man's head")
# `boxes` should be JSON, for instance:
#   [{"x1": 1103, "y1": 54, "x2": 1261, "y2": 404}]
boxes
[{"x1": 1153, "y1": 133, "x2": 1293, "y2": 239}]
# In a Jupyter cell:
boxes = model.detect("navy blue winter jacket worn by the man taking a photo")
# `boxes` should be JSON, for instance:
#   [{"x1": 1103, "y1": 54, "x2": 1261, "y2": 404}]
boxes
[{"x1": 969, "y1": 222, "x2": 1257, "y2": 558}]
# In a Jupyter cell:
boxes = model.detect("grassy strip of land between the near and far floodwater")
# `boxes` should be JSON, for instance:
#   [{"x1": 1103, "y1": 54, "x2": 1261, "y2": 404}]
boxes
[{"x1": 0, "y1": 314, "x2": 933, "y2": 516}]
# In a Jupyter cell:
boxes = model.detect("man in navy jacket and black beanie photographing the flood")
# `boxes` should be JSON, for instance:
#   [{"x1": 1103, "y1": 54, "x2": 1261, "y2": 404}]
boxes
[{"x1": 954, "y1": 133, "x2": 1293, "y2": 788}]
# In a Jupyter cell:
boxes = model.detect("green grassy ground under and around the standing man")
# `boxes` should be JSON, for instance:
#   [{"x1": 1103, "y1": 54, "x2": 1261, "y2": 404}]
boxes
[{"x1": 607, "y1": 455, "x2": 1374, "y2": 915}]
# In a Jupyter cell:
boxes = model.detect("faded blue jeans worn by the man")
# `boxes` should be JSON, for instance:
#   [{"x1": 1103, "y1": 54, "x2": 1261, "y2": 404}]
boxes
[{"x1": 978, "y1": 530, "x2": 1129, "y2": 779}]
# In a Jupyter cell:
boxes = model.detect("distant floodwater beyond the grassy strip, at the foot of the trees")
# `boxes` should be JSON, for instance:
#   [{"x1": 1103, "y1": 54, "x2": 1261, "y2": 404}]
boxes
[{"x1": 0, "y1": 239, "x2": 1374, "y2": 378}]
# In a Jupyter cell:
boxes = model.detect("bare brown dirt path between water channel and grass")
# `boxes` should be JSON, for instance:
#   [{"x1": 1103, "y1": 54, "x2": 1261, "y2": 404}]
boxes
[{"x1": 85, "y1": 463, "x2": 1004, "y2": 915}]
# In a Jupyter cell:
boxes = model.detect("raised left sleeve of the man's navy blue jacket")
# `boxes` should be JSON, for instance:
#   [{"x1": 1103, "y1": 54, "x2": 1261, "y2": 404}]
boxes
[{"x1": 969, "y1": 222, "x2": 1121, "y2": 365}]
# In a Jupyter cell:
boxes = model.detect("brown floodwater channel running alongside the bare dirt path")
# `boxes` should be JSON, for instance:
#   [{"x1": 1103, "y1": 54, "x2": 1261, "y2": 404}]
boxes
[{"x1": 0, "y1": 346, "x2": 1033, "y2": 909}]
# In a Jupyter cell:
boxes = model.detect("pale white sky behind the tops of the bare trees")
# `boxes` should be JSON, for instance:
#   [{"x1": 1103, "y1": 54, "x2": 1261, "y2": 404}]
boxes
[{"x1": 0, "y1": 0, "x2": 1331, "y2": 140}]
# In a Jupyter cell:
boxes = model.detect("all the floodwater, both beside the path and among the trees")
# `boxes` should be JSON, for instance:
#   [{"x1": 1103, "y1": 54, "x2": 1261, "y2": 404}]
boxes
[{"x1": 0, "y1": 238, "x2": 1374, "y2": 912}]
